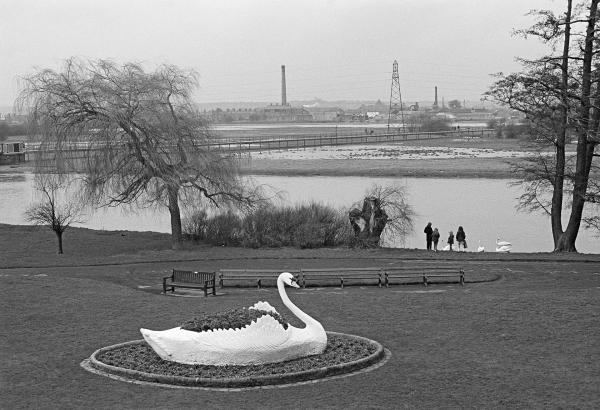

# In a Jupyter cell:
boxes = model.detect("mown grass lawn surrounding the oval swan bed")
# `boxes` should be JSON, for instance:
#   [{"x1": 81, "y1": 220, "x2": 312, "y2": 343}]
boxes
[{"x1": 0, "y1": 226, "x2": 600, "y2": 409}]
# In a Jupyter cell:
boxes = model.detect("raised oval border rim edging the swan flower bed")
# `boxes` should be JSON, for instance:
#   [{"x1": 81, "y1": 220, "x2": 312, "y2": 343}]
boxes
[{"x1": 81, "y1": 332, "x2": 391, "y2": 390}]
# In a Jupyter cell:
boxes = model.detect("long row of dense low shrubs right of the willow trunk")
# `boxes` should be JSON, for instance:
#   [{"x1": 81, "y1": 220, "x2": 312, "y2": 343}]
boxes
[{"x1": 183, "y1": 203, "x2": 354, "y2": 248}]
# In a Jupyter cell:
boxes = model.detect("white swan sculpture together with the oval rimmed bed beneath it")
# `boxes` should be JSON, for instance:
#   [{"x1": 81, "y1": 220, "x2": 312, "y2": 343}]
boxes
[{"x1": 82, "y1": 272, "x2": 389, "y2": 388}]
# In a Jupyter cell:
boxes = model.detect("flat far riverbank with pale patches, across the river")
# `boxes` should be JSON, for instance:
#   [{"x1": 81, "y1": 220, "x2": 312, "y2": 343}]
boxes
[{"x1": 242, "y1": 138, "x2": 552, "y2": 179}]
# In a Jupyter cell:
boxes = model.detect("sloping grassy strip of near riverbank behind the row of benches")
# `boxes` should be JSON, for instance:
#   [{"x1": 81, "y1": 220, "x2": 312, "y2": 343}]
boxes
[{"x1": 0, "y1": 224, "x2": 600, "y2": 270}]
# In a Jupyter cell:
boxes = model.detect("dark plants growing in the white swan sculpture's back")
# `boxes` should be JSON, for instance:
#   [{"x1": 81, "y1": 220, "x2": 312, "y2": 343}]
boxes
[{"x1": 181, "y1": 308, "x2": 288, "y2": 332}]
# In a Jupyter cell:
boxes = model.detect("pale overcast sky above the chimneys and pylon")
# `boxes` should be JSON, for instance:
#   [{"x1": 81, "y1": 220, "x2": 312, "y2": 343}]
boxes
[{"x1": 0, "y1": 0, "x2": 566, "y2": 106}]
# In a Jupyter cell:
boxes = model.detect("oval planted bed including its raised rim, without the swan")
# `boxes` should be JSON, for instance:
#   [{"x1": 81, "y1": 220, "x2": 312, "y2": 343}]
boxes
[{"x1": 89, "y1": 332, "x2": 386, "y2": 388}]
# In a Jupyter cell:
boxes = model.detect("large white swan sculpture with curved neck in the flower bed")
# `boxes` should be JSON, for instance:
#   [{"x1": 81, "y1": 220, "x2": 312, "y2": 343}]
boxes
[{"x1": 140, "y1": 272, "x2": 327, "y2": 366}]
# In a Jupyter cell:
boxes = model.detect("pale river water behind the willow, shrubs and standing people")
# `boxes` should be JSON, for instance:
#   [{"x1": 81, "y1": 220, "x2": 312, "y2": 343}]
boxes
[{"x1": 0, "y1": 173, "x2": 600, "y2": 253}]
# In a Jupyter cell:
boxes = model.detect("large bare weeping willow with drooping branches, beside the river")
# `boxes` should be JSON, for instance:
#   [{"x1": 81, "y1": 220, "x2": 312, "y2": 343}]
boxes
[{"x1": 17, "y1": 58, "x2": 260, "y2": 249}]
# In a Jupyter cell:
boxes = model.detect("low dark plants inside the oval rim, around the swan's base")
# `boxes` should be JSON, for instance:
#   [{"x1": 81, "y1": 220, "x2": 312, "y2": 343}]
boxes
[{"x1": 97, "y1": 334, "x2": 377, "y2": 379}]
